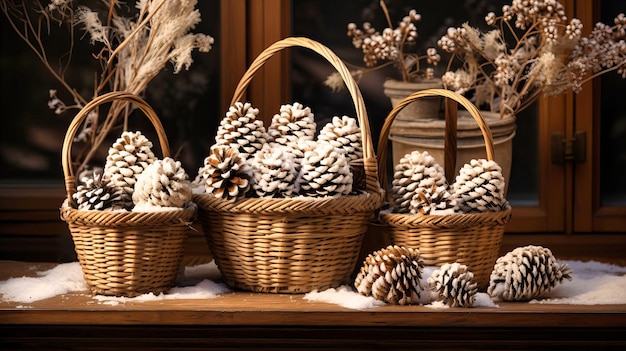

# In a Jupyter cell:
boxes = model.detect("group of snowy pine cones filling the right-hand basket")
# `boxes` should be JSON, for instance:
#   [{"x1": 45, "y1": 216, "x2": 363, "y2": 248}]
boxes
[{"x1": 391, "y1": 151, "x2": 507, "y2": 215}]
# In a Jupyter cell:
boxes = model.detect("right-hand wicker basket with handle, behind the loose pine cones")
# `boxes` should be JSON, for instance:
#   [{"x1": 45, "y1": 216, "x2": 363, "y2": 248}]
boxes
[{"x1": 377, "y1": 89, "x2": 511, "y2": 289}]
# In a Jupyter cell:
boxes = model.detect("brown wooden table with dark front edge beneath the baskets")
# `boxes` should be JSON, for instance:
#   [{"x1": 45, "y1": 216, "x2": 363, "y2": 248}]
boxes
[{"x1": 0, "y1": 261, "x2": 626, "y2": 350}]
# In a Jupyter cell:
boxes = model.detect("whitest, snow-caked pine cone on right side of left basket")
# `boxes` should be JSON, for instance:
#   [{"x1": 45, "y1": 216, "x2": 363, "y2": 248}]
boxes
[{"x1": 133, "y1": 157, "x2": 191, "y2": 207}]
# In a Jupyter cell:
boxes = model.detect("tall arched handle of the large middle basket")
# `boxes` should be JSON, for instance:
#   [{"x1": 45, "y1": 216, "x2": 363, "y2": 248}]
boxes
[{"x1": 231, "y1": 37, "x2": 380, "y2": 197}]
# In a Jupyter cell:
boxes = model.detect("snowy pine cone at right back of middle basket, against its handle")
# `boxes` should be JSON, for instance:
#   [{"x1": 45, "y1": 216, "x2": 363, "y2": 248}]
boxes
[{"x1": 317, "y1": 116, "x2": 365, "y2": 189}]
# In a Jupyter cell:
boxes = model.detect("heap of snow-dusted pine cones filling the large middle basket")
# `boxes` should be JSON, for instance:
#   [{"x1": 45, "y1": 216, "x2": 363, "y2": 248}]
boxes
[{"x1": 194, "y1": 102, "x2": 363, "y2": 200}]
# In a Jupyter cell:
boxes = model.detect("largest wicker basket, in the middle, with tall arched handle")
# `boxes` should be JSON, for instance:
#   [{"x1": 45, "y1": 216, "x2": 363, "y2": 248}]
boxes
[{"x1": 194, "y1": 38, "x2": 383, "y2": 293}]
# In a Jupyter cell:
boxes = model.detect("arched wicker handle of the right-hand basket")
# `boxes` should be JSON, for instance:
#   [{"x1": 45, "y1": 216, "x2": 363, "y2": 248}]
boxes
[{"x1": 377, "y1": 89, "x2": 494, "y2": 187}]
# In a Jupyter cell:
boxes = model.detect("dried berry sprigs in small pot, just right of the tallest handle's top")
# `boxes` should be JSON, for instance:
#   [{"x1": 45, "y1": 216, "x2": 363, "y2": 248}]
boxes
[{"x1": 325, "y1": 1, "x2": 443, "y2": 120}]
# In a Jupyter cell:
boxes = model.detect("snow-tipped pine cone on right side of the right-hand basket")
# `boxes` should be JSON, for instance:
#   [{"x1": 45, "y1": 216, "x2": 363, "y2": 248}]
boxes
[{"x1": 453, "y1": 159, "x2": 507, "y2": 213}]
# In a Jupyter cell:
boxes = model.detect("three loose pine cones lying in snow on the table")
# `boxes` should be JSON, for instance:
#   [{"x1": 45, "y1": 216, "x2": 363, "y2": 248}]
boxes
[{"x1": 354, "y1": 245, "x2": 572, "y2": 307}]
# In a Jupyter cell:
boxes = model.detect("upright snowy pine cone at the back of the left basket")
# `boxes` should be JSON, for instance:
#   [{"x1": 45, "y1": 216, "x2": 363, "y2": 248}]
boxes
[{"x1": 103, "y1": 132, "x2": 157, "y2": 209}]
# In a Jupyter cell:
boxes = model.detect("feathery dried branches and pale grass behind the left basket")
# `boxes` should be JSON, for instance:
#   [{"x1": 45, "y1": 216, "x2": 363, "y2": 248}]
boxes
[{"x1": 0, "y1": 0, "x2": 214, "y2": 170}]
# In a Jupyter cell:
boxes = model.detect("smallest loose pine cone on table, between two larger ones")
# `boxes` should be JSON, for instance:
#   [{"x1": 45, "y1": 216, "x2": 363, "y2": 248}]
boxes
[{"x1": 428, "y1": 263, "x2": 478, "y2": 307}]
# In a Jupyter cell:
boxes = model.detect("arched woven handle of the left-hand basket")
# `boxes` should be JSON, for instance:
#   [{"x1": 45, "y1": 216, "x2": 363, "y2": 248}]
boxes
[{"x1": 61, "y1": 91, "x2": 170, "y2": 207}]
